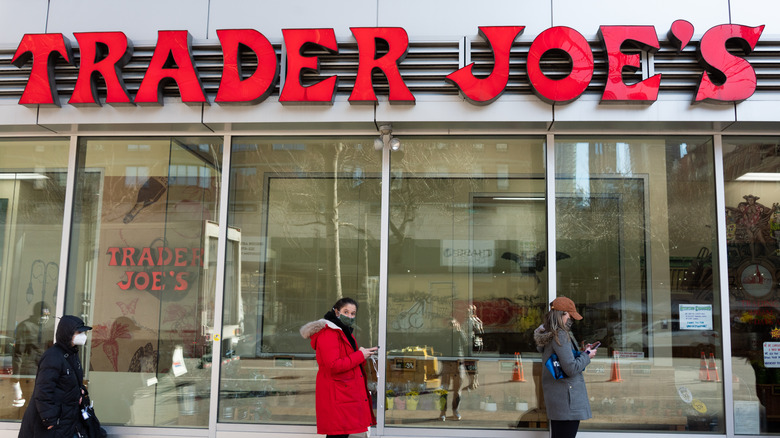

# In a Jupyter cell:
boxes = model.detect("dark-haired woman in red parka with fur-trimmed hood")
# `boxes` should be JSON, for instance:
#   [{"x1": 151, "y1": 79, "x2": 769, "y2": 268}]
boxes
[{"x1": 301, "y1": 298, "x2": 377, "y2": 438}]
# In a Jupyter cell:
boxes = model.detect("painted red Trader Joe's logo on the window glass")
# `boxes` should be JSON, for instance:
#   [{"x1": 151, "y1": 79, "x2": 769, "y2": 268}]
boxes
[{"x1": 106, "y1": 247, "x2": 203, "y2": 291}]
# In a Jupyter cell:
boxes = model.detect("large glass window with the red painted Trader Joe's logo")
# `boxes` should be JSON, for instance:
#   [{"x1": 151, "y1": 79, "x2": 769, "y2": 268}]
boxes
[{"x1": 65, "y1": 137, "x2": 222, "y2": 427}]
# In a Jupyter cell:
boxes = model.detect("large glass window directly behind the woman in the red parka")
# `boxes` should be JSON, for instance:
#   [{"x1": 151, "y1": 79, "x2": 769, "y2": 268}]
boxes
[{"x1": 218, "y1": 137, "x2": 382, "y2": 424}]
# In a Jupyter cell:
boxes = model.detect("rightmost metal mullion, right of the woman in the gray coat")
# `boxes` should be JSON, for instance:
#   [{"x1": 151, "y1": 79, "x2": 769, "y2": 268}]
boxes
[{"x1": 713, "y1": 134, "x2": 735, "y2": 437}]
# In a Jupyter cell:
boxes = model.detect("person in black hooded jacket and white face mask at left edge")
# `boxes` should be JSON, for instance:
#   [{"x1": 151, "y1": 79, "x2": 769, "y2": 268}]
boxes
[{"x1": 19, "y1": 315, "x2": 92, "y2": 438}]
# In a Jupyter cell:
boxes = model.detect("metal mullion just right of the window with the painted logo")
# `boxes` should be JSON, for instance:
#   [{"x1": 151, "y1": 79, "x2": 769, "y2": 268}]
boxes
[{"x1": 204, "y1": 134, "x2": 232, "y2": 438}]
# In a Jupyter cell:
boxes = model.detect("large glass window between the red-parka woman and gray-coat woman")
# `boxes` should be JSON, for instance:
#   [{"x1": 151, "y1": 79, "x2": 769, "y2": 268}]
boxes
[{"x1": 385, "y1": 138, "x2": 548, "y2": 429}]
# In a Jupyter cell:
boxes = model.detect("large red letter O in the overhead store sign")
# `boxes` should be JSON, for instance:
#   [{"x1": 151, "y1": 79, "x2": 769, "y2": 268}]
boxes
[{"x1": 526, "y1": 26, "x2": 593, "y2": 103}]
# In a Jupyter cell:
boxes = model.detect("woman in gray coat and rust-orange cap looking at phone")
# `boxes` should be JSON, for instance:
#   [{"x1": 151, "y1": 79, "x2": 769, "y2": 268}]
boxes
[{"x1": 534, "y1": 297, "x2": 596, "y2": 438}]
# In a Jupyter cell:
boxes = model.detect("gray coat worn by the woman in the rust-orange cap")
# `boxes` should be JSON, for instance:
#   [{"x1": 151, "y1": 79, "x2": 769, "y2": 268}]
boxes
[{"x1": 534, "y1": 326, "x2": 593, "y2": 420}]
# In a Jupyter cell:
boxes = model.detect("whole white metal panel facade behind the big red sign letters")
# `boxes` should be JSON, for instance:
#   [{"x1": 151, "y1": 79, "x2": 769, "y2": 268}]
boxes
[{"x1": 0, "y1": 0, "x2": 780, "y2": 132}]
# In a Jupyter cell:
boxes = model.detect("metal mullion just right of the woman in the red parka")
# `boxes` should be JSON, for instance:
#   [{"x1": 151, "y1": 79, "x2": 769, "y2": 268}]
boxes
[{"x1": 376, "y1": 140, "x2": 390, "y2": 436}]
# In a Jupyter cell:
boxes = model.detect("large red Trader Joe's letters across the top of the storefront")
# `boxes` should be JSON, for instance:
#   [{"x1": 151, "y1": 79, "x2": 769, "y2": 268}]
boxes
[{"x1": 11, "y1": 20, "x2": 764, "y2": 106}]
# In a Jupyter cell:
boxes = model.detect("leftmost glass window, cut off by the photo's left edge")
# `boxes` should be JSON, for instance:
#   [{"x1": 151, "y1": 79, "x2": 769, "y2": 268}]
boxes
[{"x1": 0, "y1": 139, "x2": 69, "y2": 420}]
